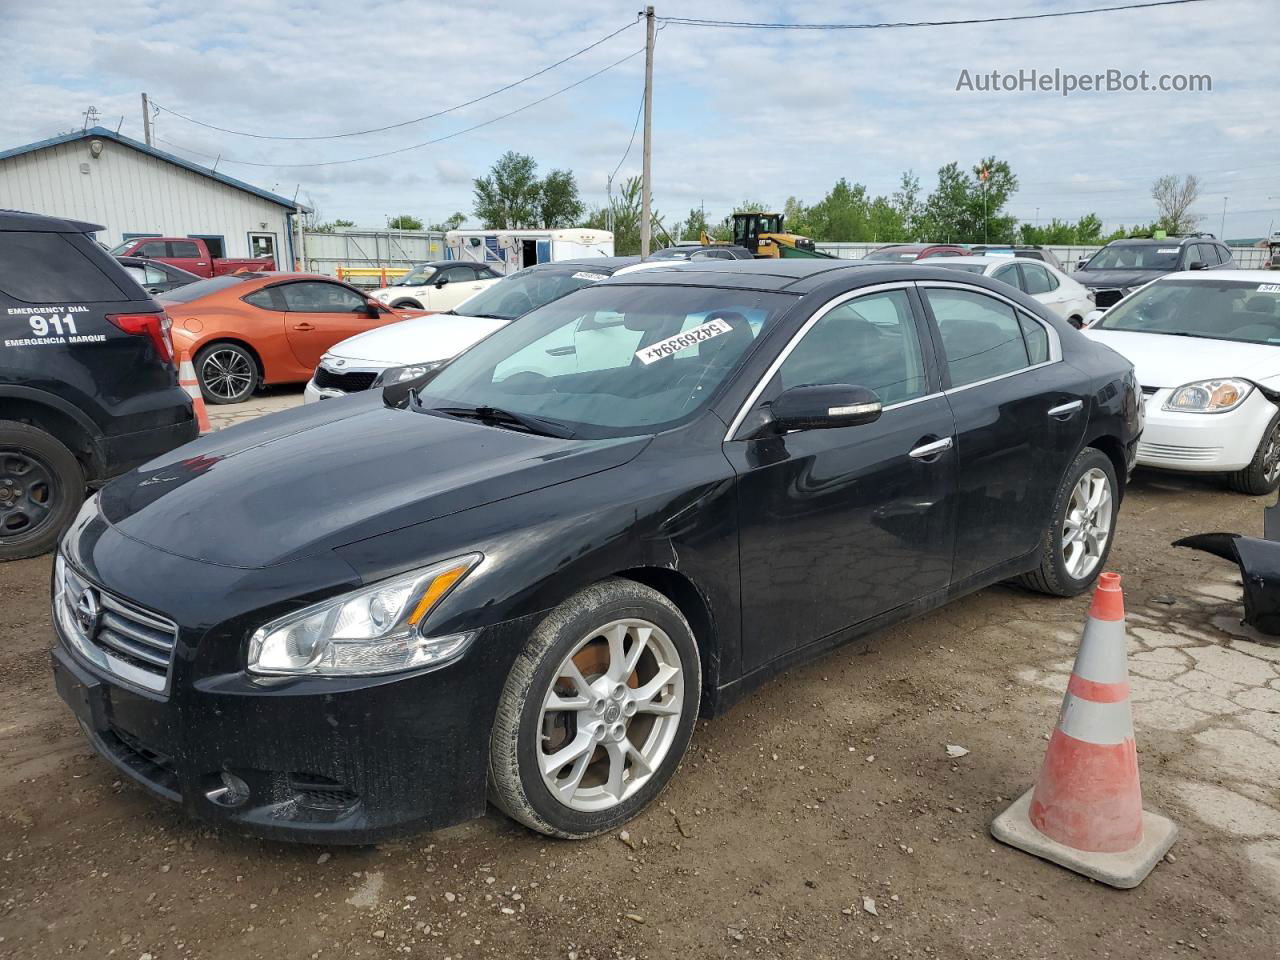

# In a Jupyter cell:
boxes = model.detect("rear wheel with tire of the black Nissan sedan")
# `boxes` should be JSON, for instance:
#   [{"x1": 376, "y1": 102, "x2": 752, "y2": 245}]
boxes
[{"x1": 1018, "y1": 447, "x2": 1120, "y2": 596}]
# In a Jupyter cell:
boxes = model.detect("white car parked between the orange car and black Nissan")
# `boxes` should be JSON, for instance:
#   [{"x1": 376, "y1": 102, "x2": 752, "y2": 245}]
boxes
[{"x1": 302, "y1": 257, "x2": 672, "y2": 403}]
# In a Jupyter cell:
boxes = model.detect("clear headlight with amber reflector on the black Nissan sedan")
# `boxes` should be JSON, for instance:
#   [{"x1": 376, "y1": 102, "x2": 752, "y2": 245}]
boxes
[{"x1": 248, "y1": 553, "x2": 480, "y2": 677}]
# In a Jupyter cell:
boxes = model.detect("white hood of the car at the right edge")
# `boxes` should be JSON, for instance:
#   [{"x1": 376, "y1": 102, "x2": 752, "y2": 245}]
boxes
[{"x1": 1084, "y1": 328, "x2": 1280, "y2": 388}]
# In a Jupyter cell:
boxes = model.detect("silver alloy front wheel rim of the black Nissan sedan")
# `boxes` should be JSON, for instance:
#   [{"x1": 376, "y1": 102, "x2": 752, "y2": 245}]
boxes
[{"x1": 538, "y1": 620, "x2": 685, "y2": 812}]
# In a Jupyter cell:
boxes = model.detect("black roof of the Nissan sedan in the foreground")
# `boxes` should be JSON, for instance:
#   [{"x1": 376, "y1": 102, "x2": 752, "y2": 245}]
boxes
[{"x1": 603, "y1": 257, "x2": 1007, "y2": 294}]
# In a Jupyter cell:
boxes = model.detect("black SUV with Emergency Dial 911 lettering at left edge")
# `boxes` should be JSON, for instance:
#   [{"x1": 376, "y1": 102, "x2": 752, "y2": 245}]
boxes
[{"x1": 0, "y1": 210, "x2": 198, "y2": 561}]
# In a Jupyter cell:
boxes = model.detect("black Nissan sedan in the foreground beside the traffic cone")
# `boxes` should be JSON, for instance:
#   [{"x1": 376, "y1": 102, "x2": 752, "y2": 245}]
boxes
[{"x1": 54, "y1": 260, "x2": 1142, "y2": 842}]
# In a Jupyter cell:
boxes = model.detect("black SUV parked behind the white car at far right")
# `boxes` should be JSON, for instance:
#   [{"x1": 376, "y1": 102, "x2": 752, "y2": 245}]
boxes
[{"x1": 1071, "y1": 233, "x2": 1238, "y2": 310}]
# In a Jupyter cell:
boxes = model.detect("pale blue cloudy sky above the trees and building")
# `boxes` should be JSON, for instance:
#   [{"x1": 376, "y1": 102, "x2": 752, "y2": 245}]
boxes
[{"x1": 0, "y1": 0, "x2": 1280, "y2": 237}]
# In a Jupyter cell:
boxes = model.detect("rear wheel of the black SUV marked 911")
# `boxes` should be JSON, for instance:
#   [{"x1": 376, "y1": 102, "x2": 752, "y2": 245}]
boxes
[{"x1": 0, "y1": 420, "x2": 84, "y2": 561}]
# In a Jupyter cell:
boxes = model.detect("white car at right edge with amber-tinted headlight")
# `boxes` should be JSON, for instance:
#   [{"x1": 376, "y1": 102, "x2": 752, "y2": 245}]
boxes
[{"x1": 1084, "y1": 270, "x2": 1280, "y2": 495}]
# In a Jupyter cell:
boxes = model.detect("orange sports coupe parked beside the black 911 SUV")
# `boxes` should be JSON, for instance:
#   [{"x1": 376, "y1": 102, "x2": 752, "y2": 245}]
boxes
[{"x1": 156, "y1": 273, "x2": 424, "y2": 403}]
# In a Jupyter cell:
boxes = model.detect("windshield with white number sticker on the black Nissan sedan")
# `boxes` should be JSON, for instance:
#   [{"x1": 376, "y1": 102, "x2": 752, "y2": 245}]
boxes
[{"x1": 419, "y1": 284, "x2": 796, "y2": 438}]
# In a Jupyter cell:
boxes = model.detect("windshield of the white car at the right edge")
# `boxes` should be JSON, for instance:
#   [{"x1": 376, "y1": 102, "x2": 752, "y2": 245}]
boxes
[{"x1": 1094, "y1": 280, "x2": 1280, "y2": 346}]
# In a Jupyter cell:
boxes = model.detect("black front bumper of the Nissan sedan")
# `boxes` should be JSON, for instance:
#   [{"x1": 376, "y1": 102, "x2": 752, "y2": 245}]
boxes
[{"x1": 52, "y1": 586, "x2": 532, "y2": 844}]
